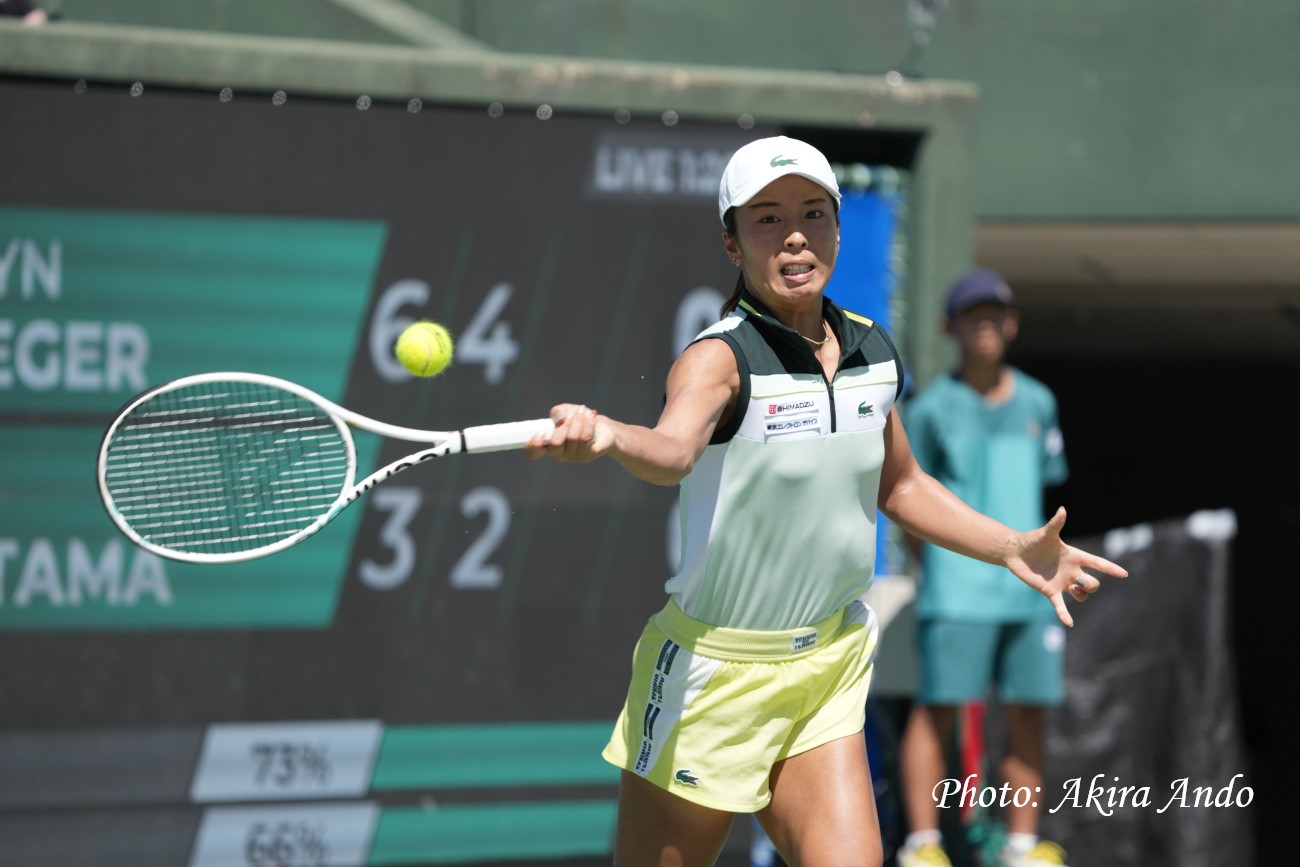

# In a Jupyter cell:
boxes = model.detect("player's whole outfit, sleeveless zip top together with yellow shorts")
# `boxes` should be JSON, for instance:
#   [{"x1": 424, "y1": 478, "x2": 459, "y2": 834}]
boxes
[{"x1": 603, "y1": 292, "x2": 902, "y2": 812}]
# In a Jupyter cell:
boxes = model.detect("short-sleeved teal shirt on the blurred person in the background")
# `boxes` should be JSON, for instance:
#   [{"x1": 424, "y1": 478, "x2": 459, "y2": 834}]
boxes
[{"x1": 904, "y1": 368, "x2": 1069, "y2": 623}]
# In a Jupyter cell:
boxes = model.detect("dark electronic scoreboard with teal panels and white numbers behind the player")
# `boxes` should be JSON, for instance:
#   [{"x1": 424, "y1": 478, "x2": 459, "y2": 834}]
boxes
[{"x1": 0, "y1": 79, "x2": 893, "y2": 867}]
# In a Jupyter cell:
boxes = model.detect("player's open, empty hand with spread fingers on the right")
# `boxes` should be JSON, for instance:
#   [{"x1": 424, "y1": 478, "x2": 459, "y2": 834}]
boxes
[{"x1": 1006, "y1": 508, "x2": 1128, "y2": 627}]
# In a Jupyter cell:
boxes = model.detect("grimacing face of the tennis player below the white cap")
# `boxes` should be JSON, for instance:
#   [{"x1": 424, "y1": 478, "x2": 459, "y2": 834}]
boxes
[{"x1": 723, "y1": 174, "x2": 840, "y2": 309}]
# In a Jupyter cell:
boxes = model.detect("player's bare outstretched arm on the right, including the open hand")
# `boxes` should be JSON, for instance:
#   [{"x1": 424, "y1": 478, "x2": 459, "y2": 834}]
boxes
[{"x1": 879, "y1": 407, "x2": 1128, "y2": 627}]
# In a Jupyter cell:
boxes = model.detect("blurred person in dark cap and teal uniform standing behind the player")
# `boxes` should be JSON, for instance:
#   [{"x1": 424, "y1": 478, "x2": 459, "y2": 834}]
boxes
[{"x1": 898, "y1": 269, "x2": 1069, "y2": 867}]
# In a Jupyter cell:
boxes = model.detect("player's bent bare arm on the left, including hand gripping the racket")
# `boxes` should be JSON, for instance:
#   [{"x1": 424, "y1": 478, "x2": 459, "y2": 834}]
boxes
[{"x1": 525, "y1": 339, "x2": 740, "y2": 485}]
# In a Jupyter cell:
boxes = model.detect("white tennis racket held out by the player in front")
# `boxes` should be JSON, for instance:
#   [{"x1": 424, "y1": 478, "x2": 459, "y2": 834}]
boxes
[{"x1": 98, "y1": 372, "x2": 554, "y2": 563}]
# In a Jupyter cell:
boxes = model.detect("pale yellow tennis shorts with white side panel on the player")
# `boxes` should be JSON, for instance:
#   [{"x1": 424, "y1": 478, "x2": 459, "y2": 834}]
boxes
[{"x1": 603, "y1": 601, "x2": 878, "y2": 812}]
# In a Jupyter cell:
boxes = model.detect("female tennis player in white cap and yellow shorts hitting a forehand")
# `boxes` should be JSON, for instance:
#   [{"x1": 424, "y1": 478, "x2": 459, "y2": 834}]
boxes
[{"x1": 527, "y1": 136, "x2": 1127, "y2": 867}]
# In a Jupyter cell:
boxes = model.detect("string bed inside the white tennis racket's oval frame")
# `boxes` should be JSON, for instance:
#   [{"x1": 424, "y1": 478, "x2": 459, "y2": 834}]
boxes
[{"x1": 104, "y1": 382, "x2": 354, "y2": 554}]
